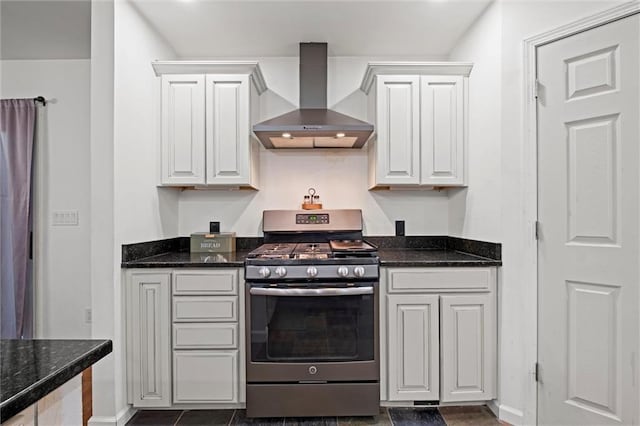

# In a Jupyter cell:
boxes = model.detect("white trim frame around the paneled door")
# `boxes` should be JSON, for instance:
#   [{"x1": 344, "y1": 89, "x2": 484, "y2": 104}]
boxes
[{"x1": 522, "y1": 0, "x2": 640, "y2": 424}]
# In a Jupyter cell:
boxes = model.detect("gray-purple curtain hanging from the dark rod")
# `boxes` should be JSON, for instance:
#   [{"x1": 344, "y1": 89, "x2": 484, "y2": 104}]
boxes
[{"x1": 0, "y1": 99, "x2": 37, "y2": 339}]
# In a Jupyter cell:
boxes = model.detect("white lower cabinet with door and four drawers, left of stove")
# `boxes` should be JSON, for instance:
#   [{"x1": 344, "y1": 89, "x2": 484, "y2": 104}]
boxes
[{"x1": 125, "y1": 268, "x2": 245, "y2": 408}]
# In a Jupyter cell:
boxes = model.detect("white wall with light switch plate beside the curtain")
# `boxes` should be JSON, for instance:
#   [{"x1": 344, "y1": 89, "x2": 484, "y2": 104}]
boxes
[{"x1": 0, "y1": 60, "x2": 91, "y2": 338}]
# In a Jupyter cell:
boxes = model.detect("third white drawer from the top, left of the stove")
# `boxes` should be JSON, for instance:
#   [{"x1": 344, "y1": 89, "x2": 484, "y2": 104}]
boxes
[{"x1": 173, "y1": 323, "x2": 238, "y2": 349}]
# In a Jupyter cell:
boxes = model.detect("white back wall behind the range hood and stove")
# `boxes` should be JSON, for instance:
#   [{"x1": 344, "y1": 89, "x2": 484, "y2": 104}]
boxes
[{"x1": 178, "y1": 57, "x2": 448, "y2": 236}]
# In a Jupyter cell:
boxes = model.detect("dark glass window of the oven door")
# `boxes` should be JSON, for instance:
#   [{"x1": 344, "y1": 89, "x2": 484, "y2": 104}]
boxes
[{"x1": 250, "y1": 288, "x2": 375, "y2": 362}]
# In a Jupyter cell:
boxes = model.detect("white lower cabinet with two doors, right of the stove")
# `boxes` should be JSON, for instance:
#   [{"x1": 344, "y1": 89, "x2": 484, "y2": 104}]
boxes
[{"x1": 381, "y1": 268, "x2": 497, "y2": 402}]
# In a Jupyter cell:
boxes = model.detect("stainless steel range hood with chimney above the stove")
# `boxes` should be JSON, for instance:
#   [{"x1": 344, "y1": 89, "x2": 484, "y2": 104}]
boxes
[{"x1": 253, "y1": 43, "x2": 373, "y2": 149}]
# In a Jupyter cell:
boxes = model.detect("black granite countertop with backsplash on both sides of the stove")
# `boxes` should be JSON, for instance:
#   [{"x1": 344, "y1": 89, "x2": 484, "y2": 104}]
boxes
[{"x1": 121, "y1": 235, "x2": 502, "y2": 268}]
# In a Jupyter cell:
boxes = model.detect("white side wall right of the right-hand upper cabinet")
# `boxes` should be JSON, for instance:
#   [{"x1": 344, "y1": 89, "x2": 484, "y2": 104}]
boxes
[{"x1": 449, "y1": 2, "x2": 502, "y2": 241}]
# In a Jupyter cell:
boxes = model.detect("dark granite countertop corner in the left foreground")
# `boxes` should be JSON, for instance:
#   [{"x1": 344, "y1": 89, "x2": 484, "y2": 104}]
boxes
[{"x1": 0, "y1": 340, "x2": 113, "y2": 422}]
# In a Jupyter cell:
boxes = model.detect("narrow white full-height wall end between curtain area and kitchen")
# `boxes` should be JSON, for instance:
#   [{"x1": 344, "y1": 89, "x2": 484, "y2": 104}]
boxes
[{"x1": 89, "y1": 0, "x2": 116, "y2": 425}]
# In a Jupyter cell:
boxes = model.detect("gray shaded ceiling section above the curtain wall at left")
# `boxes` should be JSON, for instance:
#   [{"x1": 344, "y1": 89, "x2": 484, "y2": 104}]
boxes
[{"x1": 0, "y1": 0, "x2": 91, "y2": 59}]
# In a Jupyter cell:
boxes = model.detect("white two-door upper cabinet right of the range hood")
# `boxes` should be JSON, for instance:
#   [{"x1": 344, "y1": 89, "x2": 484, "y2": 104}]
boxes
[{"x1": 360, "y1": 62, "x2": 473, "y2": 189}]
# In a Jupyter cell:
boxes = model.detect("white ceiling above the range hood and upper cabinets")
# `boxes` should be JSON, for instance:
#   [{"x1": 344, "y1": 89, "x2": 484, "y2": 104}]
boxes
[{"x1": 132, "y1": 0, "x2": 492, "y2": 59}]
